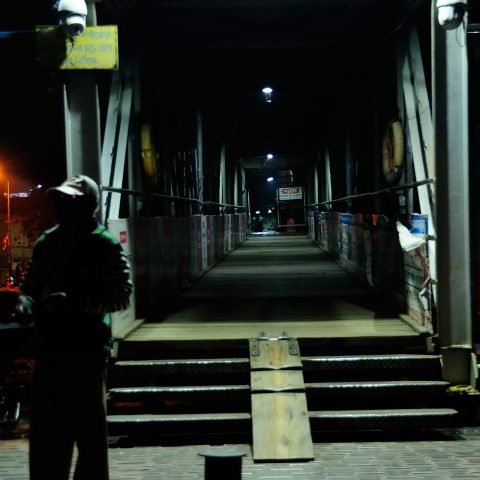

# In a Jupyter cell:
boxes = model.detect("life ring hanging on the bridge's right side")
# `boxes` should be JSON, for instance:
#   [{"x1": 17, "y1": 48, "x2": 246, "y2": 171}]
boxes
[{"x1": 382, "y1": 120, "x2": 405, "y2": 184}]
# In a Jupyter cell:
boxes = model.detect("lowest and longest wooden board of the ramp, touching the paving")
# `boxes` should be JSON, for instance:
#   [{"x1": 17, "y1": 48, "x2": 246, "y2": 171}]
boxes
[{"x1": 252, "y1": 392, "x2": 314, "y2": 462}]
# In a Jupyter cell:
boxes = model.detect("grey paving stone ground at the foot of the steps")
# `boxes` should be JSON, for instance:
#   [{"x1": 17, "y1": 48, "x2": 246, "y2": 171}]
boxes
[{"x1": 0, "y1": 428, "x2": 480, "y2": 480}]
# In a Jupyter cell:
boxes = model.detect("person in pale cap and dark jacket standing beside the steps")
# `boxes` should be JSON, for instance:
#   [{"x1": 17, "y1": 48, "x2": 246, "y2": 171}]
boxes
[{"x1": 17, "y1": 175, "x2": 132, "y2": 480}]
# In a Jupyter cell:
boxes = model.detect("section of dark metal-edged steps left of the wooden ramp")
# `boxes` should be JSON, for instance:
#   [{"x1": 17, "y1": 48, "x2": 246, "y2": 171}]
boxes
[{"x1": 108, "y1": 341, "x2": 251, "y2": 445}]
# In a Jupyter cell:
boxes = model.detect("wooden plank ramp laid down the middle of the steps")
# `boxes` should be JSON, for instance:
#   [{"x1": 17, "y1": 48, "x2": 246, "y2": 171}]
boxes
[{"x1": 250, "y1": 335, "x2": 314, "y2": 462}]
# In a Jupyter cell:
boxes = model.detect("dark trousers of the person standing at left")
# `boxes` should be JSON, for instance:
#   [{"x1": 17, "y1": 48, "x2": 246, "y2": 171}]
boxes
[{"x1": 29, "y1": 361, "x2": 108, "y2": 480}]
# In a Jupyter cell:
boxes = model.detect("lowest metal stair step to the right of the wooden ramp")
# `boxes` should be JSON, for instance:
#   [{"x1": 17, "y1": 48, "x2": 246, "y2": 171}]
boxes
[{"x1": 309, "y1": 408, "x2": 458, "y2": 431}]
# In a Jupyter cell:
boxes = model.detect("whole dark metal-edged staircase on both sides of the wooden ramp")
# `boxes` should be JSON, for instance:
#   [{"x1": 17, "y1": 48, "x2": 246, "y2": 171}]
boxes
[{"x1": 108, "y1": 334, "x2": 459, "y2": 445}]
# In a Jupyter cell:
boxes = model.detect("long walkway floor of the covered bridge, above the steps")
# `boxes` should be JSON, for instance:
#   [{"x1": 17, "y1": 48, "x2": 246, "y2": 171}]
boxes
[{"x1": 128, "y1": 235, "x2": 417, "y2": 341}]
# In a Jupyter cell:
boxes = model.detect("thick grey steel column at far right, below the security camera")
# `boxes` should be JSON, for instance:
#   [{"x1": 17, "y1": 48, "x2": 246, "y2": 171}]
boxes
[{"x1": 432, "y1": 2, "x2": 472, "y2": 384}]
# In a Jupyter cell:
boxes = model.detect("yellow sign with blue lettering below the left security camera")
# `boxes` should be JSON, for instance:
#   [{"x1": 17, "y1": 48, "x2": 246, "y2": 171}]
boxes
[{"x1": 37, "y1": 25, "x2": 118, "y2": 70}]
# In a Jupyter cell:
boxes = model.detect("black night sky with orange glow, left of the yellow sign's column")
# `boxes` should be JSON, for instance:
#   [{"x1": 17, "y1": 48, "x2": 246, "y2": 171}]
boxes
[{"x1": 0, "y1": 0, "x2": 65, "y2": 192}]
